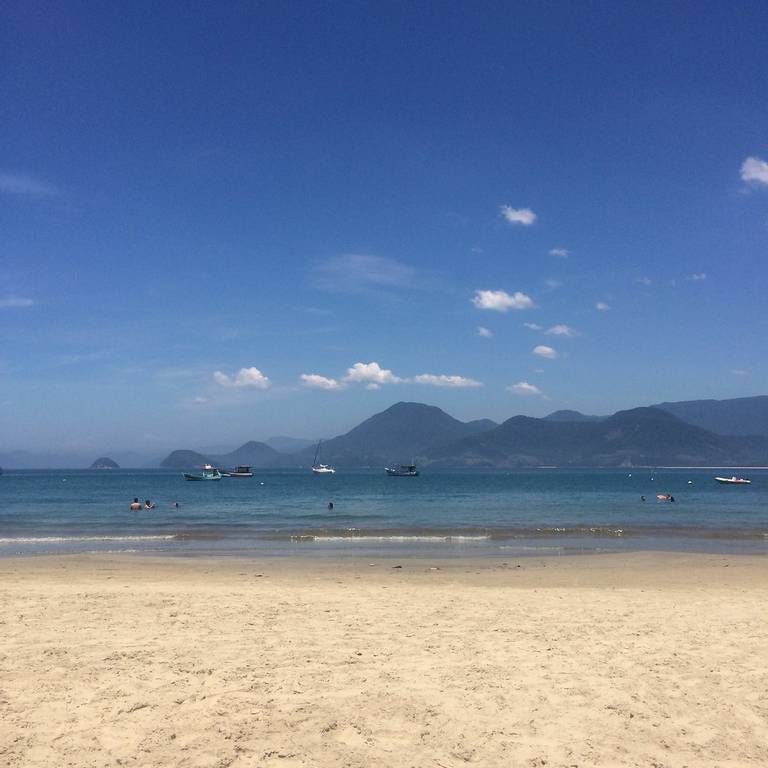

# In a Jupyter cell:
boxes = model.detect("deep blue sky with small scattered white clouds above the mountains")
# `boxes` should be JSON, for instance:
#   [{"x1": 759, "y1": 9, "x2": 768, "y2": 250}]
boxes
[{"x1": 0, "y1": 2, "x2": 768, "y2": 453}]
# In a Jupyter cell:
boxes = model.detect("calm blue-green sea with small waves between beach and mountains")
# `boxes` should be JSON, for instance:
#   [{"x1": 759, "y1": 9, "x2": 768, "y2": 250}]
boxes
[{"x1": 0, "y1": 469, "x2": 768, "y2": 557}]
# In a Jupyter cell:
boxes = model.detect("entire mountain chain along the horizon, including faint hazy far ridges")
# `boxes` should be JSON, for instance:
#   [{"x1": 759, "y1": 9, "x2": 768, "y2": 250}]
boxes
[{"x1": 6, "y1": 395, "x2": 768, "y2": 469}]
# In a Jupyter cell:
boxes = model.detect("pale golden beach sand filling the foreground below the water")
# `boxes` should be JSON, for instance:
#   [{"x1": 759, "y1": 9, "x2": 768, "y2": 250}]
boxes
[{"x1": 0, "y1": 554, "x2": 768, "y2": 768}]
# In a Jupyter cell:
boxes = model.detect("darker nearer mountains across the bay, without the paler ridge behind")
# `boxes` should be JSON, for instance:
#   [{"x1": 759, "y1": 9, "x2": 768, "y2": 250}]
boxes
[{"x1": 162, "y1": 403, "x2": 768, "y2": 468}]
